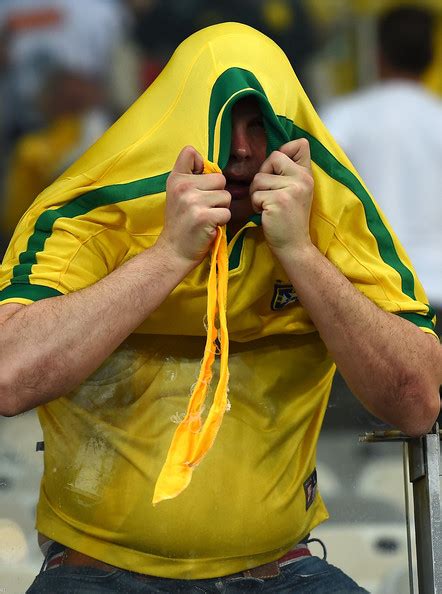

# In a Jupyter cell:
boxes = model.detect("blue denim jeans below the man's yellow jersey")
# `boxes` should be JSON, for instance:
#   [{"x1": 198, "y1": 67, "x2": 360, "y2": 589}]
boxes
[{"x1": 27, "y1": 556, "x2": 367, "y2": 594}]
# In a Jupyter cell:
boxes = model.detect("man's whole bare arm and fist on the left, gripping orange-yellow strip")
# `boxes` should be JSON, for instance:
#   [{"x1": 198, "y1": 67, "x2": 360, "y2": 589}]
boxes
[{"x1": 0, "y1": 147, "x2": 230, "y2": 416}]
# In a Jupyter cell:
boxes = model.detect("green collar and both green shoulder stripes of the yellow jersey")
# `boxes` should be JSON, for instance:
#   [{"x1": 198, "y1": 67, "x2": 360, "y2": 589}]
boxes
[{"x1": 1, "y1": 68, "x2": 432, "y2": 330}]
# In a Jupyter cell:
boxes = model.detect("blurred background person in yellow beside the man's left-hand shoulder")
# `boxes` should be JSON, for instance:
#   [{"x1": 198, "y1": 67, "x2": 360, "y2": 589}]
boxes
[{"x1": 0, "y1": 69, "x2": 111, "y2": 241}]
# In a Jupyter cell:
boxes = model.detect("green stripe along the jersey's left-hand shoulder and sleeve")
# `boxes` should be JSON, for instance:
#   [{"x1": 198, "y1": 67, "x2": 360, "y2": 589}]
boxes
[{"x1": 11, "y1": 173, "x2": 169, "y2": 285}]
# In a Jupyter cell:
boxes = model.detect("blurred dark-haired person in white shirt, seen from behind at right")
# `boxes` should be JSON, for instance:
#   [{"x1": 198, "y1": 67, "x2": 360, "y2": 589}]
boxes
[{"x1": 321, "y1": 6, "x2": 442, "y2": 334}]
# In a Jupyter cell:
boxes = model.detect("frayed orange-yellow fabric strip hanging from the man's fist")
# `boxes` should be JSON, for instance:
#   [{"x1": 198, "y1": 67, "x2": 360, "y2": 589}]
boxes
[{"x1": 152, "y1": 162, "x2": 229, "y2": 505}]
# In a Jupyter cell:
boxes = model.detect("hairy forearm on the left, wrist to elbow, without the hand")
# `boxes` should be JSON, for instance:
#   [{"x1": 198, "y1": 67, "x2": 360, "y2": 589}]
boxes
[{"x1": 0, "y1": 246, "x2": 190, "y2": 415}]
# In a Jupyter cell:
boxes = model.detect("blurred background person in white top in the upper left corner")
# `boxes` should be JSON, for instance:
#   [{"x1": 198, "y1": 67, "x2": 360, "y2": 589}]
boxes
[{"x1": 0, "y1": 0, "x2": 127, "y2": 145}]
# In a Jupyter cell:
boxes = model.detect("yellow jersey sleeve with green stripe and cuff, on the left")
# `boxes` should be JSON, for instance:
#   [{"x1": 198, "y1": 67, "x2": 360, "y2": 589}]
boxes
[{"x1": 0, "y1": 207, "x2": 129, "y2": 304}]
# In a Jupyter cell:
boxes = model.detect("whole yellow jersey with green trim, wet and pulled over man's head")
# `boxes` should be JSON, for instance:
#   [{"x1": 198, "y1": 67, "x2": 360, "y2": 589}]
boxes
[{"x1": 0, "y1": 23, "x2": 434, "y2": 578}]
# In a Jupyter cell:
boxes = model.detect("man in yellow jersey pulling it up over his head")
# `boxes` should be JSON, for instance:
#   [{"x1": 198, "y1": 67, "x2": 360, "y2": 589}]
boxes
[{"x1": 0, "y1": 23, "x2": 442, "y2": 593}]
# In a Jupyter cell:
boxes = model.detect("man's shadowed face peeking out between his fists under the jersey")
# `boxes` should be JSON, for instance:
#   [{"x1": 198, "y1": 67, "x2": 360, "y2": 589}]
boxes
[{"x1": 223, "y1": 97, "x2": 267, "y2": 231}]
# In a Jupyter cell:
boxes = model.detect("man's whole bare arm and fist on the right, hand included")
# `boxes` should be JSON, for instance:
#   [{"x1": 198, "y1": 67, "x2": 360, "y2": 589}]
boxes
[{"x1": 252, "y1": 141, "x2": 442, "y2": 435}]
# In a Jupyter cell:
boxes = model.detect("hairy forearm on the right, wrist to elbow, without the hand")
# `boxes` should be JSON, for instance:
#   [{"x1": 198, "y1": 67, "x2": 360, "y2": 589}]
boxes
[{"x1": 276, "y1": 246, "x2": 442, "y2": 435}]
